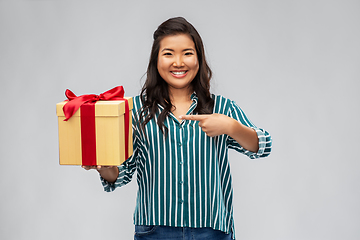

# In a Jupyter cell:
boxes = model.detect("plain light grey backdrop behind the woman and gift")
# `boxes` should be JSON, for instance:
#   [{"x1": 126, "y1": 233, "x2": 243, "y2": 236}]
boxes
[{"x1": 0, "y1": 0, "x2": 360, "y2": 240}]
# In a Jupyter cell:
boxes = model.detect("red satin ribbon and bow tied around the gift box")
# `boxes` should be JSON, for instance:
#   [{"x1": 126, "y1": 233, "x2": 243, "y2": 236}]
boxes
[{"x1": 63, "y1": 86, "x2": 129, "y2": 166}]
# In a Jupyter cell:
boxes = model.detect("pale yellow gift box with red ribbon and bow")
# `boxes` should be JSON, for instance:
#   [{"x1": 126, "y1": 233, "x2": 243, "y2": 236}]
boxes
[{"x1": 56, "y1": 87, "x2": 133, "y2": 166}]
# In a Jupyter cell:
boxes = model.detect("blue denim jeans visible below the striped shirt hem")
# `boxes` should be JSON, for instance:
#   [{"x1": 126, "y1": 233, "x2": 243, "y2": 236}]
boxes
[{"x1": 134, "y1": 225, "x2": 231, "y2": 240}]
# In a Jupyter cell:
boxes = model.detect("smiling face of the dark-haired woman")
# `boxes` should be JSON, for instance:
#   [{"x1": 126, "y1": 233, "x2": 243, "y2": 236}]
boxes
[{"x1": 157, "y1": 34, "x2": 199, "y2": 91}]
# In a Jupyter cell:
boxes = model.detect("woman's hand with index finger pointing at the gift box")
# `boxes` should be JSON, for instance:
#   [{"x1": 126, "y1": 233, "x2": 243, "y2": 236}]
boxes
[{"x1": 179, "y1": 113, "x2": 236, "y2": 137}]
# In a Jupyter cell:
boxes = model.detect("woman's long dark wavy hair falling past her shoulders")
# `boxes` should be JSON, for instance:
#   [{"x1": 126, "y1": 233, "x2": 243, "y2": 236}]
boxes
[{"x1": 140, "y1": 17, "x2": 214, "y2": 133}]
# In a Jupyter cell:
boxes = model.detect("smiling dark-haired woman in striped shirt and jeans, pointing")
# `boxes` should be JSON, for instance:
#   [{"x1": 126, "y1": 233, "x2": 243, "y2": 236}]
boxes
[{"x1": 84, "y1": 17, "x2": 271, "y2": 240}]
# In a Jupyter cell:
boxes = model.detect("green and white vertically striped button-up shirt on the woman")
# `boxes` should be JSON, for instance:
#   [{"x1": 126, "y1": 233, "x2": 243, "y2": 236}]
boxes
[{"x1": 101, "y1": 93, "x2": 272, "y2": 236}]
